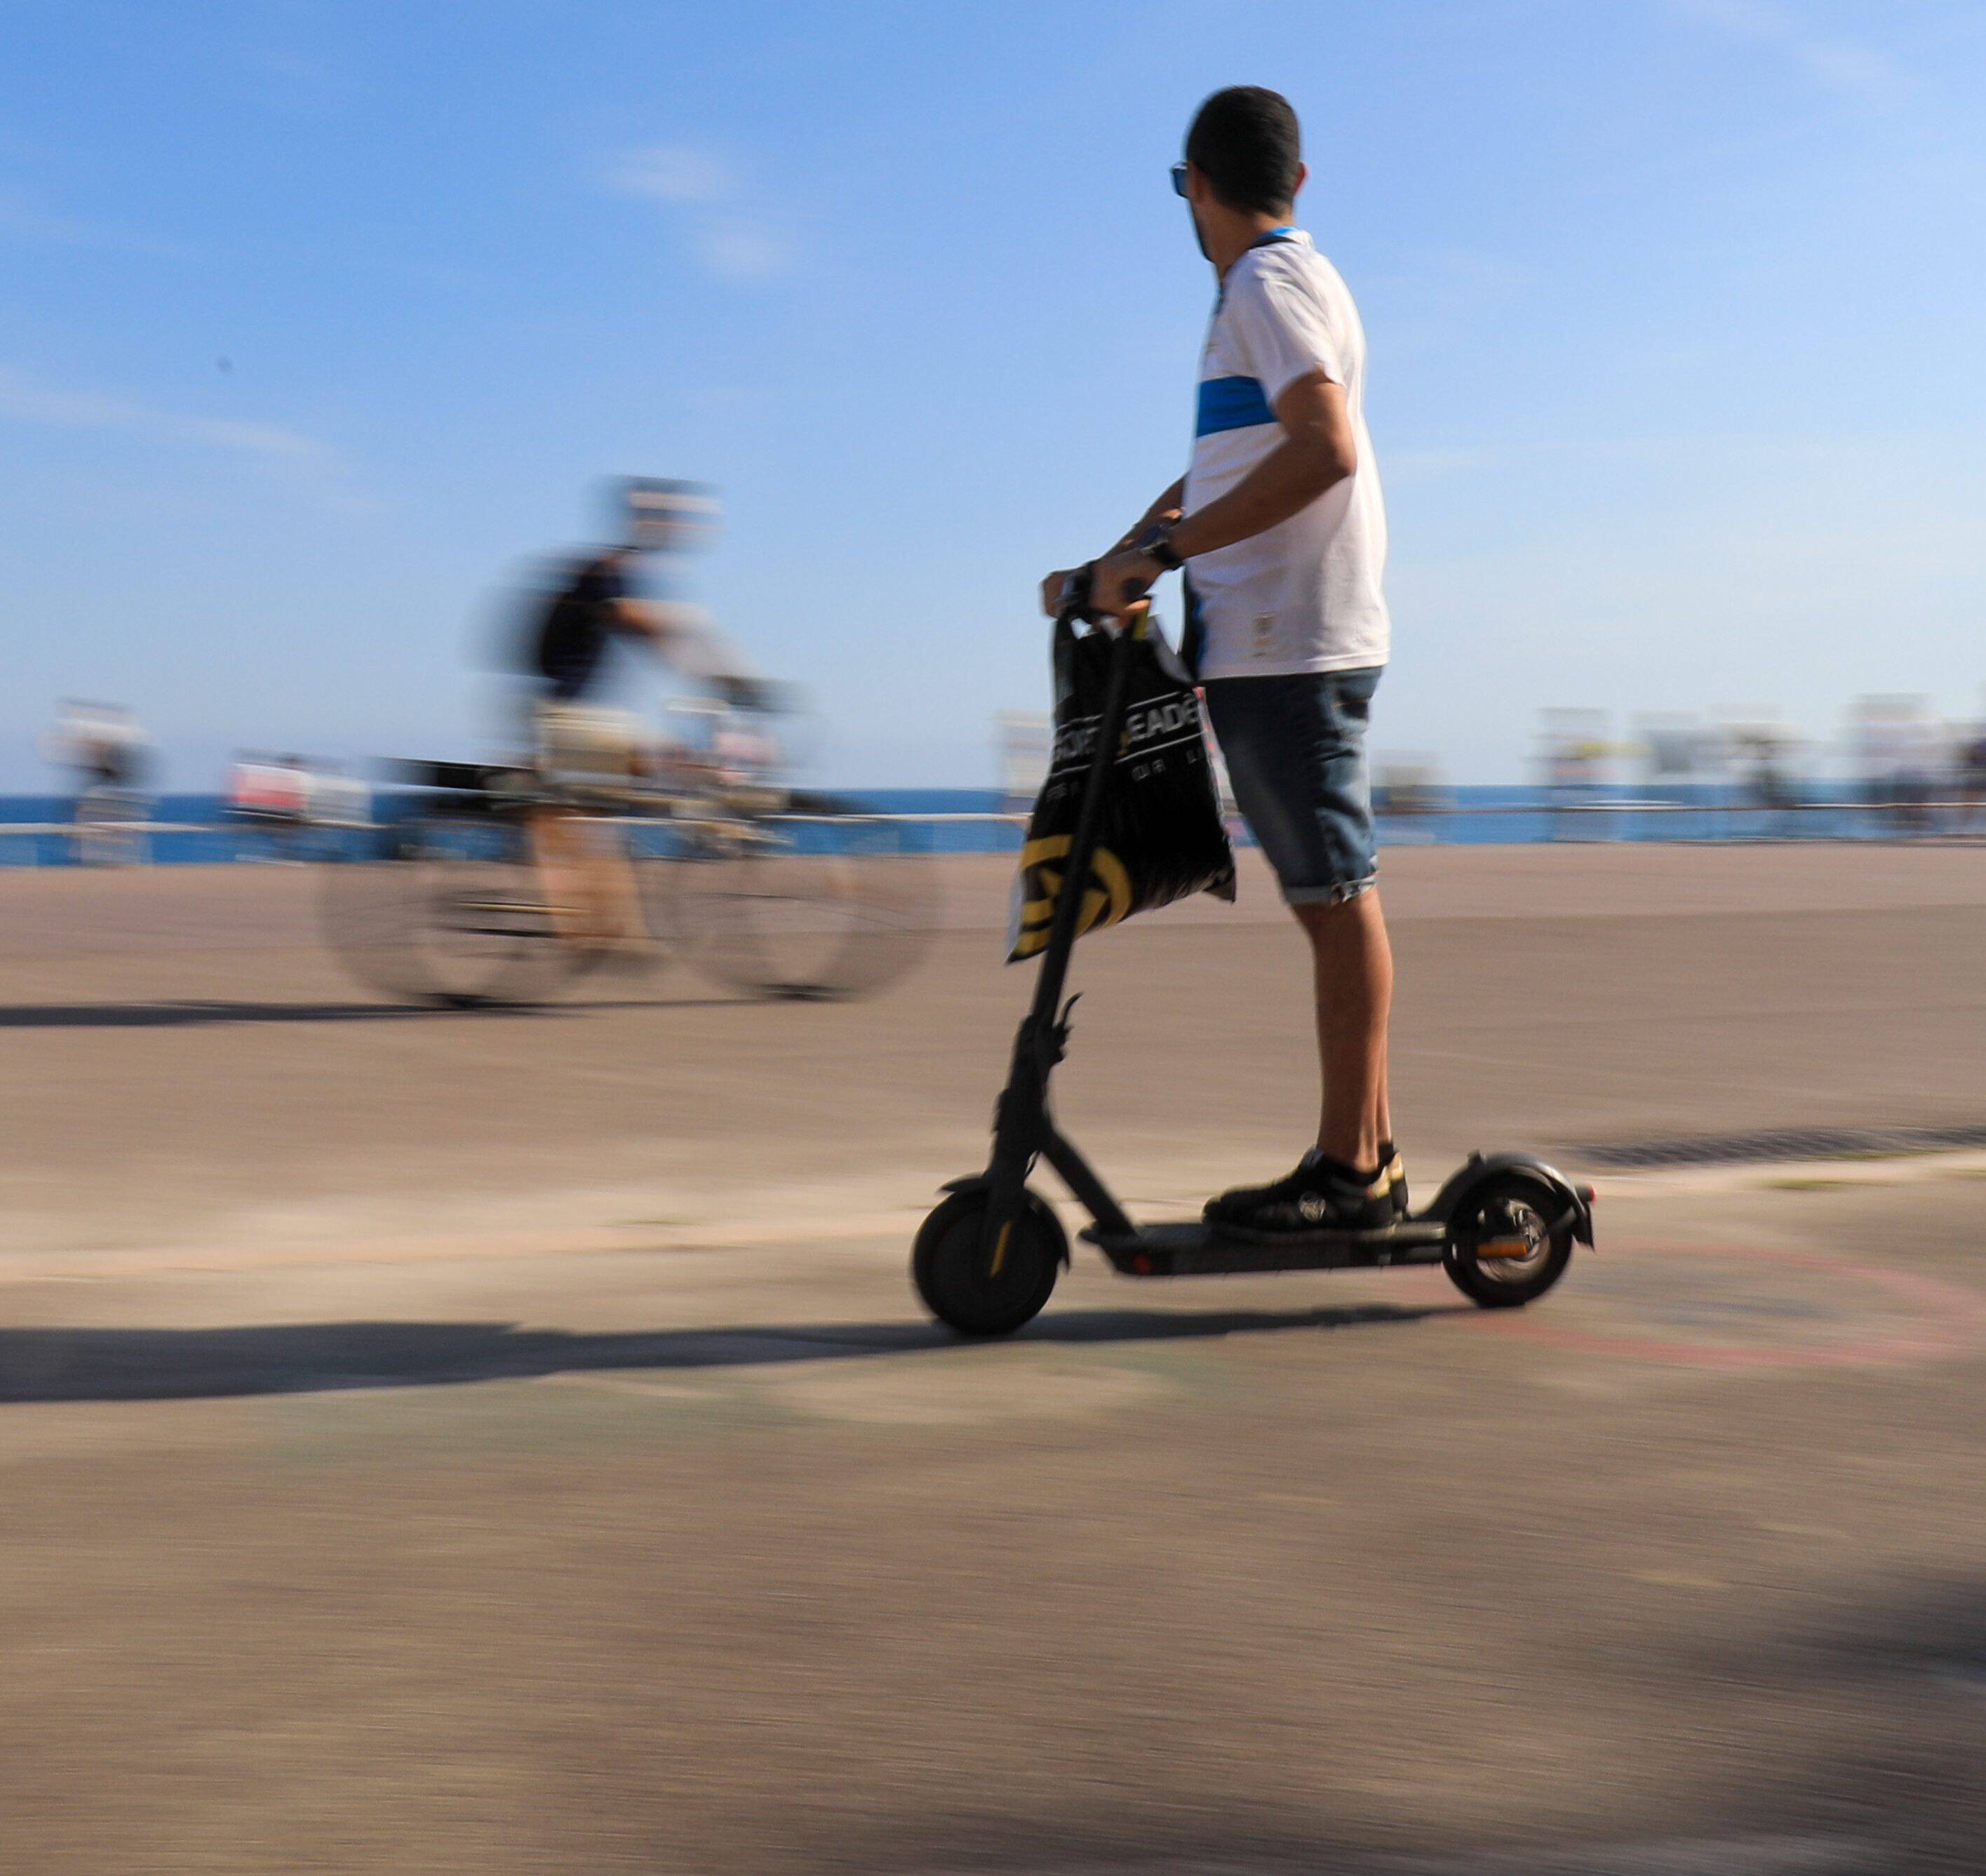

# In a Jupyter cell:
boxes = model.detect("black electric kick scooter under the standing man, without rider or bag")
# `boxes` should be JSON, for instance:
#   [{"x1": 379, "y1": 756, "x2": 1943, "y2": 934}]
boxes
[{"x1": 910, "y1": 568, "x2": 1592, "y2": 1336}]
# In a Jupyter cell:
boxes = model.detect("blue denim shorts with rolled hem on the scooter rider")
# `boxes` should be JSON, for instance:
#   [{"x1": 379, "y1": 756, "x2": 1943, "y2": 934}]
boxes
[{"x1": 1205, "y1": 665, "x2": 1384, "y2": 905}]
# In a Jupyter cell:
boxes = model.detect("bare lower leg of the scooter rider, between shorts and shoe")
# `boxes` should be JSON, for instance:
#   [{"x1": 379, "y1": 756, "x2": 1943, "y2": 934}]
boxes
[{"x1": 1293, "y1": 887, "x2": 1393, "y2": 1171}]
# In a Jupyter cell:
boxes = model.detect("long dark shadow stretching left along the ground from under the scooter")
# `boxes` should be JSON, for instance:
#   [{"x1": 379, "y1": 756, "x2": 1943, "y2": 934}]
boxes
[{"x1": 0, "y1": 1302, "x2": 1472, "y2": 1405}]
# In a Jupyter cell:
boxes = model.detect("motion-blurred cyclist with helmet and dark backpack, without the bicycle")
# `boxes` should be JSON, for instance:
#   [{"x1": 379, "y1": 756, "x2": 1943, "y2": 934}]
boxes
[{"x1": 524, "y1": 481, "x2": 760, "y2": 957}]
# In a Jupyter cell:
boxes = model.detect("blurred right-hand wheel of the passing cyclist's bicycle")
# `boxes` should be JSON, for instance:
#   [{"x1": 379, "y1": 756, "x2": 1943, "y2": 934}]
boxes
[{"x1": 663, "y1": 806, "x2": 935, "y2": 998}]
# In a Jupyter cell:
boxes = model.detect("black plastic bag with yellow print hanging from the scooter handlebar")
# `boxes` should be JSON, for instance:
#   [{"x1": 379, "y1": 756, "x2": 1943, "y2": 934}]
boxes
[{"x1": 1007, "y1": 622, "x2": 1235, "y2": 963}]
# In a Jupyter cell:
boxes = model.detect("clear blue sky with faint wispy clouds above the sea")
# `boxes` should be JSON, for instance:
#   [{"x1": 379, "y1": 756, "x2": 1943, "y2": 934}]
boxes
[{"x1": 0, "y1": 0, "x2": 1986, "y2": 786}]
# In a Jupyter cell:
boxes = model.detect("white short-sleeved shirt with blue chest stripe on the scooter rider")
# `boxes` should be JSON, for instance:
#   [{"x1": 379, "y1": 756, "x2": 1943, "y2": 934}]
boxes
[{"x1": 1183, "y1": 228, "x2": 1393, "y2": 679}]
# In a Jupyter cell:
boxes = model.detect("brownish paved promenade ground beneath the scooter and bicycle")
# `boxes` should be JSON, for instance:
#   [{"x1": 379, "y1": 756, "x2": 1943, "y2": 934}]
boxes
[{"x1": 0, "y1": 847, "x2": 1986, "y2": 1876}]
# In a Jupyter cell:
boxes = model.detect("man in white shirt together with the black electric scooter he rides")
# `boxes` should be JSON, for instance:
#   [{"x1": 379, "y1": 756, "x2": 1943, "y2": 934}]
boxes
[{"x1": 910, "y1": 89, "x2": 1592, "y2": 1336}]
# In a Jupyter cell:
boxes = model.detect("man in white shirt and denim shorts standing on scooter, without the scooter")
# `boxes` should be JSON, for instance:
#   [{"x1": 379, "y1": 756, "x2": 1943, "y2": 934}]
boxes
[{"x1": 1042, "y1": 86, "x2": 1408, "y2": 1241}]
